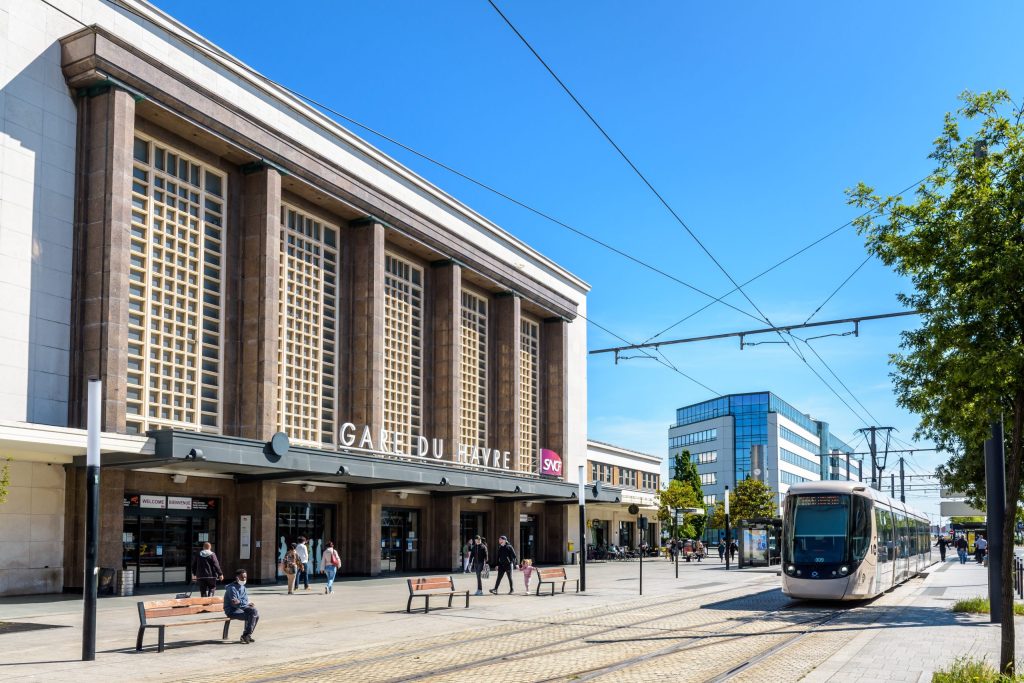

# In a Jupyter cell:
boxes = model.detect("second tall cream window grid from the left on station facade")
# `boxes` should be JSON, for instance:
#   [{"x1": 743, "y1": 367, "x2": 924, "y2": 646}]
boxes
[{"x1": 278, "y1": 205, "x2": 338, "y2": 445}]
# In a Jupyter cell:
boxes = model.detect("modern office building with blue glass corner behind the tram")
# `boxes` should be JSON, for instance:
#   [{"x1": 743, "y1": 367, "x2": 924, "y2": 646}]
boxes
[{"x1": 669, "y1": 391, "x2": 861, "y2": 528}]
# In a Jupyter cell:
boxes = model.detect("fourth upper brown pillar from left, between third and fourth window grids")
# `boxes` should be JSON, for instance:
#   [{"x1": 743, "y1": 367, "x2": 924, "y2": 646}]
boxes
[{"x1": 430, "y1": 261, "x2": 462, "y2": 458}]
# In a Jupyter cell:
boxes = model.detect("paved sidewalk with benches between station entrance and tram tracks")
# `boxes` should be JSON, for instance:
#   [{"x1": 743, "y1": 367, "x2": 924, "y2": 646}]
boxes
[{"x1": 0, "y1": 560, "x2": 778, "y2": 681}]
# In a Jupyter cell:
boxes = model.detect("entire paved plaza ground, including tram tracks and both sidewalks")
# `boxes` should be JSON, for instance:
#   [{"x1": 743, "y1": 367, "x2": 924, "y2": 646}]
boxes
[{"x1": 0, "y1": 560, "x2": 1024, "y2": 682}]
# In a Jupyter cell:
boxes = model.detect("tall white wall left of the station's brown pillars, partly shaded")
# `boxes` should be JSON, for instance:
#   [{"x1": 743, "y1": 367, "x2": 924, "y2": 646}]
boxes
[{"x1": 0, "y1": 0, "x2": 77, "y2": 426}]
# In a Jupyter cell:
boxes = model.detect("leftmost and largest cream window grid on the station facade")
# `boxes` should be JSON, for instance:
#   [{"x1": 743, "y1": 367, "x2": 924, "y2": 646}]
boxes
[{"x1": 126, "y1": 135, "x2": 226, "y2": 433}]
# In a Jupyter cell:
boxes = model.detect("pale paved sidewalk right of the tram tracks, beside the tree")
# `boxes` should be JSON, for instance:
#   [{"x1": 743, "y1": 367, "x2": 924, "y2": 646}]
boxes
[{"x1": 803, "y1": 555, "x2": 1024, "y2": 683}]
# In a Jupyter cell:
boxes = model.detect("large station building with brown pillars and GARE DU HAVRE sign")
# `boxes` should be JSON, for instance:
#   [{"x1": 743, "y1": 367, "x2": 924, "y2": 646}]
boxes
[{"x1": 0, "y1": 0, "x2": 606, "y2": 595}]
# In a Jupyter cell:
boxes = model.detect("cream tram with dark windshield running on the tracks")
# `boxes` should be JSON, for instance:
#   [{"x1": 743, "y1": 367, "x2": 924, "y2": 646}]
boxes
[{"x1": 782, "y1": 481, "x2": 934, "y2": 600}]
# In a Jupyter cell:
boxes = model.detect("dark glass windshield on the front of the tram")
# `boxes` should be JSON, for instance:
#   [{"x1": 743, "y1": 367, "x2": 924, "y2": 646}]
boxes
[{"x1": 783, "y1": 494, "x2": 871, "y2": 564}]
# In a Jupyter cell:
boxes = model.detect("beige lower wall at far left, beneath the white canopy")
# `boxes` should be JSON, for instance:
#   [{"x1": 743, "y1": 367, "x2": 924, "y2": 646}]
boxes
[{"x1": 0, "y1": 461, "x2": 65, "y2": 595}]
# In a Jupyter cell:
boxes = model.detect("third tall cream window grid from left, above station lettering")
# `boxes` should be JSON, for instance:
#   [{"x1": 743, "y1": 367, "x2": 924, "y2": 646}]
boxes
[{"x1": 384, "y1": 254, "x2": 423, "y2": 446}]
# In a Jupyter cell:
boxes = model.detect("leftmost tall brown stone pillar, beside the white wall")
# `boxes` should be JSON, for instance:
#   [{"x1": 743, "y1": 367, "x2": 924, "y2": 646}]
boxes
[{"x1": 69, "y1": 88, "x2": 135, "y2": 433}]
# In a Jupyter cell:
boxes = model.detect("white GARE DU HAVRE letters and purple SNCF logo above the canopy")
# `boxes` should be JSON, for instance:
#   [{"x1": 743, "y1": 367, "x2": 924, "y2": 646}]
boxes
[{"x1": 338, "y1": 422, "x2": 562, "y2": 478}]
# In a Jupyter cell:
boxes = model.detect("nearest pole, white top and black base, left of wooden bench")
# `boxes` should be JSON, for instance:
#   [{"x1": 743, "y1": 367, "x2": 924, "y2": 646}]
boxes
[{"x1": 82, "y1": 379, "x2": 103, "y2": 661}]
